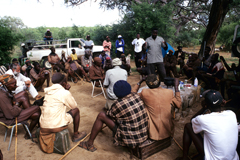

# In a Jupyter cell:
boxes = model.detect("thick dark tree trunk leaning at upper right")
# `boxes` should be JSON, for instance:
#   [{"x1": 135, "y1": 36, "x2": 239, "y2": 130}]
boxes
[{"x1": 198, "y1": 0, "x2": 232, "y2": 58}]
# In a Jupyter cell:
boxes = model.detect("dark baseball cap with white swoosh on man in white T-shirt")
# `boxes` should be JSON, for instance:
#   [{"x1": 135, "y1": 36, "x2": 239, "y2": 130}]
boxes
[{"x1": 203, "y1": 90, "x2": 223, "y2": 107}]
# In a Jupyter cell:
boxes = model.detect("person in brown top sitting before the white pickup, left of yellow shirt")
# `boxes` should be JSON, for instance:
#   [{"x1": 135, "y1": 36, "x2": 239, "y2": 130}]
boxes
[{"x1": 48, "y1": 47, "x2": 67, "y2": 73}]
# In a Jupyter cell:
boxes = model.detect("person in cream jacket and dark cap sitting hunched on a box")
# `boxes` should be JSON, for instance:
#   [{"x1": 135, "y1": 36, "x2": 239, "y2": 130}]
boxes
[{"x1": 39, "y1": 73, "x2": 86, "y2": 142}]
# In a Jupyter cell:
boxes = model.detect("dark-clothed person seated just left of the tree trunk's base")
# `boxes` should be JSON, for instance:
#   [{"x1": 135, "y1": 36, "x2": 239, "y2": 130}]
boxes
[{"x1": 182, "y1": 54, "x2": 201, "y2": 83}]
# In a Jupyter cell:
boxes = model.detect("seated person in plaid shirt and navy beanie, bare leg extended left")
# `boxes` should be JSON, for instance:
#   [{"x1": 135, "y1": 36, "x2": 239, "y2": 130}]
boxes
[{"x1": 79, "y1": 80, "x2": 148, "y2": 152}]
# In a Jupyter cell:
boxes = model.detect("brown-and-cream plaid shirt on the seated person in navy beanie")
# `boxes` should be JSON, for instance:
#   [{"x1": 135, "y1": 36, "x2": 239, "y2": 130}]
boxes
[{"x1": 107, "y1": 93, "x2": 148, "y2": 148}]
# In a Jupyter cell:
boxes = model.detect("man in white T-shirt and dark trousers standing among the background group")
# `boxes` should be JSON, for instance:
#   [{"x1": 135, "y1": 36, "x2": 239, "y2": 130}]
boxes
[{"x1": 132, "y1": 33, "x2": 145, "y2": 68}]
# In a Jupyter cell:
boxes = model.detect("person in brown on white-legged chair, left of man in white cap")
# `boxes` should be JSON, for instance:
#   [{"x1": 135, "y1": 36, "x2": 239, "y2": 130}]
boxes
[{"x1": 89, "y1": 57, "x2": 105, "y2": 86}]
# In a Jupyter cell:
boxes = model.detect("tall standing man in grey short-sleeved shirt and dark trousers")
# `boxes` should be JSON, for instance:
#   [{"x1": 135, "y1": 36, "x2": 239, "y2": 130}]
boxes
[{"x1": 146, "y1": 29, "x2": 168, "y2": 81}]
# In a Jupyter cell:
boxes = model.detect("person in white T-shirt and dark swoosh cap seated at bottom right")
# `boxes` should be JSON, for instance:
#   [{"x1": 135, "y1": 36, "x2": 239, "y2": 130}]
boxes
[{"x1": 177, "y1": 90, "x2": 239, "y2": 160}]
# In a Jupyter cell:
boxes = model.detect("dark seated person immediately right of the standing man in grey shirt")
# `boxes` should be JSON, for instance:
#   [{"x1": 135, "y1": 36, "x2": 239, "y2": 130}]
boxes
[{"x1": 164, "y1": 50, "x2": 178, "y2": 77}]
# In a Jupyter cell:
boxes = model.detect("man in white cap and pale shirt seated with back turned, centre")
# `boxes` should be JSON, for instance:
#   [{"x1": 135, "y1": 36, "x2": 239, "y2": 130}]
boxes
[{"x1": 103, "y1": 58, "x2": 128, "y2": 110}]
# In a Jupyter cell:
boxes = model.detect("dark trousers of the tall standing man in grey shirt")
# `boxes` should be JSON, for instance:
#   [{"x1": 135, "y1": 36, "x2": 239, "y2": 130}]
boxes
[{"x1": 147, "y1": 62, "x2": 166, "y2": 82}]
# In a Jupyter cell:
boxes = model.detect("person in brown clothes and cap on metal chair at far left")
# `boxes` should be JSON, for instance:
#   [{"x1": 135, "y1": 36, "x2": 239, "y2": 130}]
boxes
[{"x1": 0, "y1": 74, "x2": 40, "y2": 139}]
